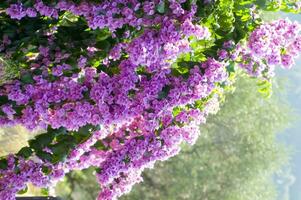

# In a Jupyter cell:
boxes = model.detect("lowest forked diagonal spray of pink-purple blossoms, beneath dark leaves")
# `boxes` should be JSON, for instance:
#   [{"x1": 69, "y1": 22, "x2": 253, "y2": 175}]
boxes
[{"x1": 0, "y1": 95, "x2": 218, "y2": 200}]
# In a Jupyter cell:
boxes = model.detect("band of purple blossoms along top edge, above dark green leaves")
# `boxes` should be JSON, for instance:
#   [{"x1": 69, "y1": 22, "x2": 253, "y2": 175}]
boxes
[{"x1": 6, "y1": 0, "x2": 199, "y2": 31}]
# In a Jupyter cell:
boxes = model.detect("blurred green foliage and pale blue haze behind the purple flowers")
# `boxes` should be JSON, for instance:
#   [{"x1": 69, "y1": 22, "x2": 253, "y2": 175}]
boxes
[{"x1": 0, "y1": 10, "x2": 301, "y2": 200}]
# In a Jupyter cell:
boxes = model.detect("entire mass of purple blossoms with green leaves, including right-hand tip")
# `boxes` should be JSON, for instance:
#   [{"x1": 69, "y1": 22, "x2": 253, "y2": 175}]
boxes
[{"x1": 0, "y1": 0, "x2": 301, "y2": 200}]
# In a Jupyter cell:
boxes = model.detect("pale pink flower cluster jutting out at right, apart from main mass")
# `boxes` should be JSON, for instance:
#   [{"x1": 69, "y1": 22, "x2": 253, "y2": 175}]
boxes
[{"x1": 236, "y1": 19, "x2": 301, "y2": 78}]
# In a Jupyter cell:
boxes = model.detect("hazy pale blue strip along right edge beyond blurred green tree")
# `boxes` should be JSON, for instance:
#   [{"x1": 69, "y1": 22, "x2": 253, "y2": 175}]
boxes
[{"x1": 277, "y1": 14, "x2": 301, "y2": 200}]
